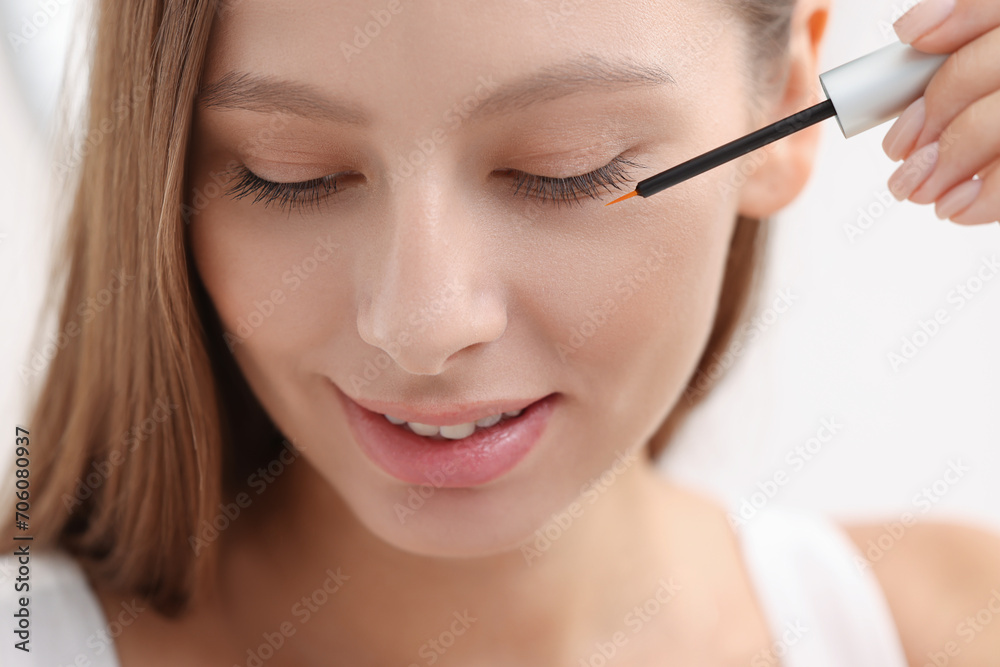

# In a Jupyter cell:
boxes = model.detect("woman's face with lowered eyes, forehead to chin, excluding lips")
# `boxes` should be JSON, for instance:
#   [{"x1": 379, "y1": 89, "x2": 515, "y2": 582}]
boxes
[{"x1": 188, "y1": 0, "x2": 752, "y2": 555}]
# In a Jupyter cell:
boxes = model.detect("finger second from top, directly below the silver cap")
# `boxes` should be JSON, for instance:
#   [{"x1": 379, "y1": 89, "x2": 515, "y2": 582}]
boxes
[{"x1": 907, "y1": 25, "x2": 1000, "y2": 155}]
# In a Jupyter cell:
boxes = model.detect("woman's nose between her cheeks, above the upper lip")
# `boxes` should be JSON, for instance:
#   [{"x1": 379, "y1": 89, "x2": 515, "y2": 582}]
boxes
[{"x1": 358, "y1": 174, "x2": 507, "y2": 375}]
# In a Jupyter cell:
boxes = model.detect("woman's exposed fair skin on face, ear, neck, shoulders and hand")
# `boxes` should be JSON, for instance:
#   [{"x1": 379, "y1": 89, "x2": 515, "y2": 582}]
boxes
[{"x1": 88, "y1": 0, "x2": 1000, "y2": 667}]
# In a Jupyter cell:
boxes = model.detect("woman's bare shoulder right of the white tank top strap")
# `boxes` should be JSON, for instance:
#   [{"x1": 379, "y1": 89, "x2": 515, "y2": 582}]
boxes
[{"x1": 843, "y1": 520, "x2": 1000, "y2": 667}]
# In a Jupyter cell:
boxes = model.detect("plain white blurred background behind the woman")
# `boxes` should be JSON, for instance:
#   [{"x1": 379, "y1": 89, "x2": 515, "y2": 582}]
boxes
[{"x1": 0, "y1": 0, "x2": 1000, "y2": 529}]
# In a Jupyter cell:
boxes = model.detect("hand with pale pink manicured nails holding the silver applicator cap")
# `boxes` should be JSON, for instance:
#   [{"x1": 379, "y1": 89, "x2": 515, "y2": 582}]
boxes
[{"x1": 882, "y1": 0, "x2": 1000, "y2": 225}]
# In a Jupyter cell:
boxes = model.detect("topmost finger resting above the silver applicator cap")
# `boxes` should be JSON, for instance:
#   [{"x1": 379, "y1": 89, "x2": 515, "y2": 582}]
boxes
[{"x1": 893, "y1": 0, "x2": 1000, "y2": 53}]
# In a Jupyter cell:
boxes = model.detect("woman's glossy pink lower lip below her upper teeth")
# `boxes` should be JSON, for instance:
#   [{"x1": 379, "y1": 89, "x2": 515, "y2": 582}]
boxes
[{"x1": 331, "y1": 383, "x2": 558, "y2": 488}]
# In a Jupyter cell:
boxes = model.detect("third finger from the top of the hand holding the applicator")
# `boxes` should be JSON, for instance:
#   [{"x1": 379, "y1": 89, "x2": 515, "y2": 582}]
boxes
[{"x1": 900, "y1": 91, "x2": 1000, "y2": 204}]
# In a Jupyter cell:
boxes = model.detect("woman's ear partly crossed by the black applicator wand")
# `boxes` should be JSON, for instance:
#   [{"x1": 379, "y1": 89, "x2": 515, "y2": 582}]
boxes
[{"x1": 739, "y1": 0, "x2": 830, "y2": 218}]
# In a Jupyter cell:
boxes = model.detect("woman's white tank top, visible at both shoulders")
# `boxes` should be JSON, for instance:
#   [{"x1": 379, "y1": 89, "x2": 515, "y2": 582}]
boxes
[{"x1": 0, "y1": 505, "x2": 907, "y2": 667}]
